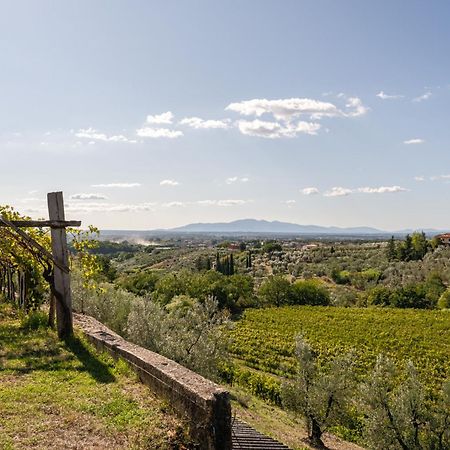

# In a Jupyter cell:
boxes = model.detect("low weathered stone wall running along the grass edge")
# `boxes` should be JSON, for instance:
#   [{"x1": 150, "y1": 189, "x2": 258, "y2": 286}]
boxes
[{"x1": 74, "y1": 314, "x2": 232, "y2": 450}]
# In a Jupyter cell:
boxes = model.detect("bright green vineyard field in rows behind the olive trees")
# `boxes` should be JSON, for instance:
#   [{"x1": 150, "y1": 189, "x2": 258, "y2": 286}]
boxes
[{"x1": 229, "y1": 306, "x2": 450, "y2": 403}]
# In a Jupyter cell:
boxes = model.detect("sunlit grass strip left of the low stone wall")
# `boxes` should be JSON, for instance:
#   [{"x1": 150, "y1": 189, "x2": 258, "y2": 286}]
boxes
[{"x1": 0, "y1": 304, "x2": 187, "y2": 449}]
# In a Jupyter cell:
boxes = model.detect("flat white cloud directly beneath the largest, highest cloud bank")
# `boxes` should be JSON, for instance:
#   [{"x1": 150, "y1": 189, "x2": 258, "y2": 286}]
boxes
[{"x1": 238, "y1": 119, "x2": 320, "y2": 139}]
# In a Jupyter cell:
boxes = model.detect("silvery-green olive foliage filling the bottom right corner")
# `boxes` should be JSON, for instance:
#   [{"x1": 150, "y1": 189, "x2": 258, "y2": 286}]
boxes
[{"x1": 361, "y1": 356, "x2": 450, "y2": 450}]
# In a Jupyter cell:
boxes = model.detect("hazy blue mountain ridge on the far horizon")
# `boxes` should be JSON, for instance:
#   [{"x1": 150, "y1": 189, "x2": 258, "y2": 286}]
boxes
[{"x1": 168, "y1": 219, "x2": 388, "y2": 235}]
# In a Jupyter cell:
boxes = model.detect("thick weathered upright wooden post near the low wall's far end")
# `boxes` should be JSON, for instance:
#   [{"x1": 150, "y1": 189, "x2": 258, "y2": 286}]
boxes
[{"x1": 47, "y1": 192, "x2": 73, "y2": 339}]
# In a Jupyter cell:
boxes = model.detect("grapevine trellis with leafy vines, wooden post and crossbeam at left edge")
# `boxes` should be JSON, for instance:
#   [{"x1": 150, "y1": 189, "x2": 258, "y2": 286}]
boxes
[{"x1": 0, "y1": 192, "x2": 81, "y2": 338}]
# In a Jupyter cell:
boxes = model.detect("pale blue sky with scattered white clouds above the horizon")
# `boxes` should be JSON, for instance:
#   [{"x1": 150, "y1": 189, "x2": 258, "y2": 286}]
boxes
[{"x1": 0, "y1": 0, "x2": 450, "y2": 231}]
